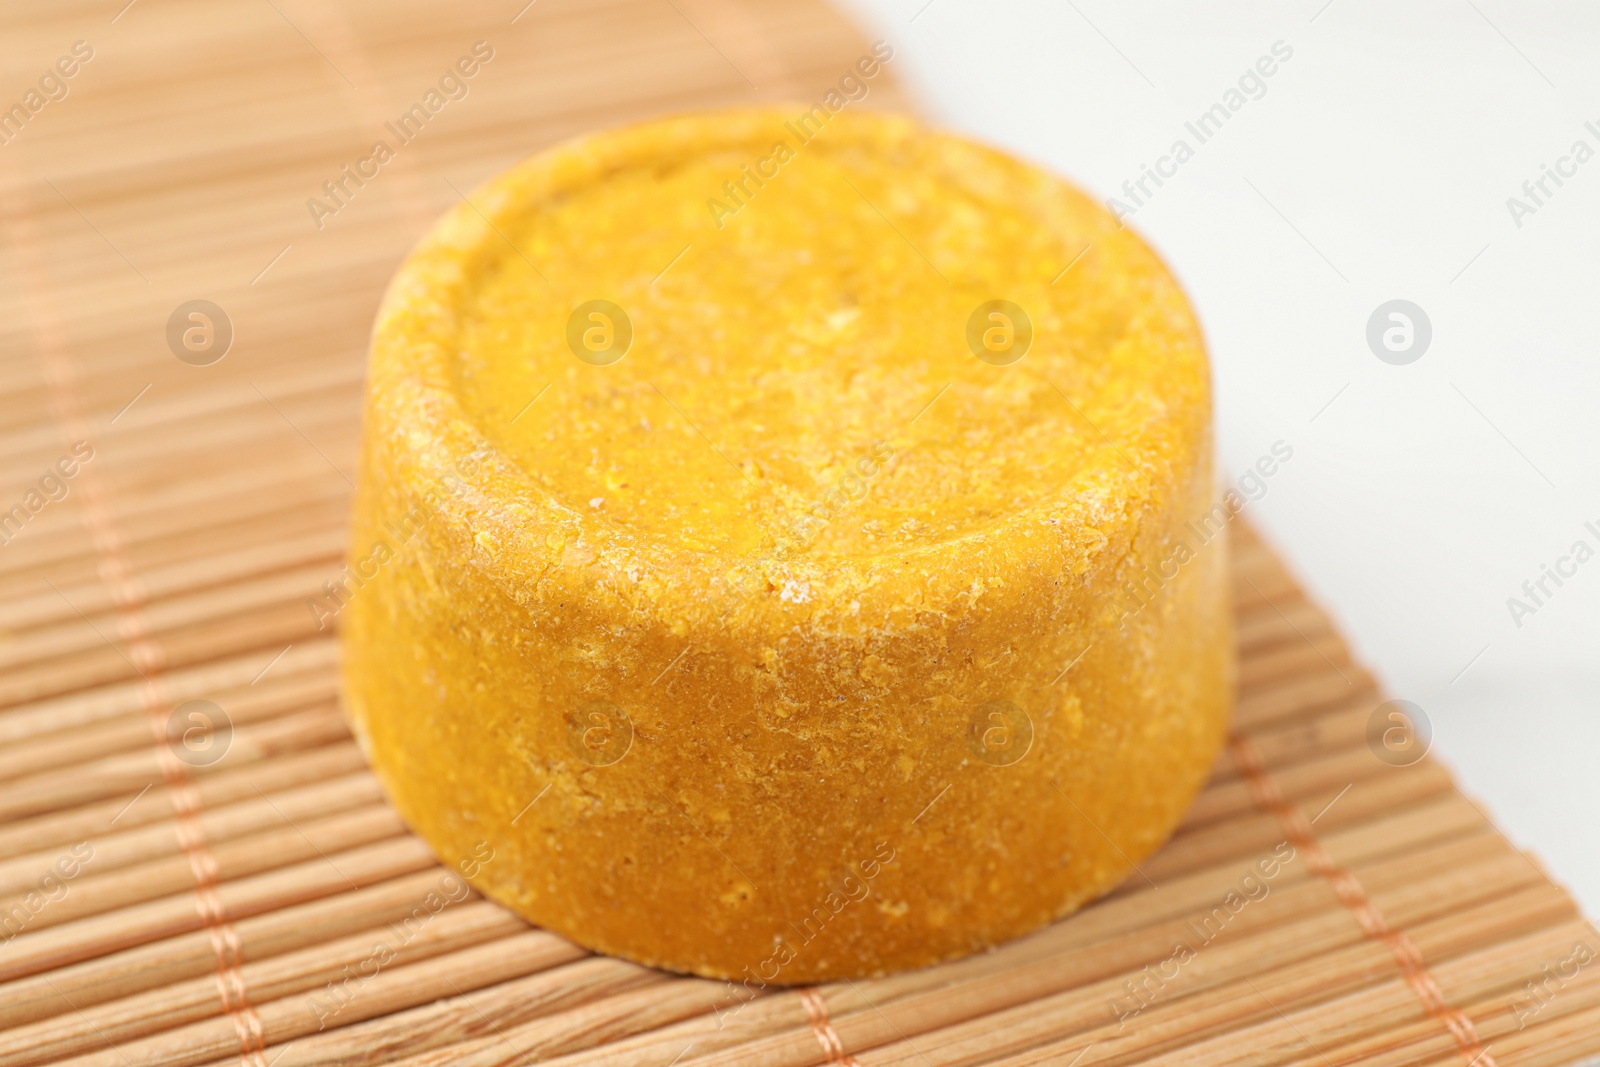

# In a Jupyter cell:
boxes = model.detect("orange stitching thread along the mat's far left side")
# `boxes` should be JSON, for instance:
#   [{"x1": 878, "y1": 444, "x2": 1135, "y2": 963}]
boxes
[{"x1": 0, "y1": 179, "x2": 266, "y2": 1067}]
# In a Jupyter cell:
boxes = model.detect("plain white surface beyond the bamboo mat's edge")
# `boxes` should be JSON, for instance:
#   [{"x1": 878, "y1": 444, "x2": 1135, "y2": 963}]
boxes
[{"x1": 853, "y1": 0, "x2": 1600, "y2": 917}]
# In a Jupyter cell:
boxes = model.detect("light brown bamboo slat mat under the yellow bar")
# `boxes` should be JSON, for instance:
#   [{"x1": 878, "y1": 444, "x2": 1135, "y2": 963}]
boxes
[{"x1": 0, "y1": 0, "x2": 1600, "y2": 1067}]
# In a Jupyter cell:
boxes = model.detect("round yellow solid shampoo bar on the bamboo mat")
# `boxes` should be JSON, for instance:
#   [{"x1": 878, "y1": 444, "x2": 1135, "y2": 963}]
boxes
[{"x1": 339, "y1": 107, "x2": 1232, "y2": 989}]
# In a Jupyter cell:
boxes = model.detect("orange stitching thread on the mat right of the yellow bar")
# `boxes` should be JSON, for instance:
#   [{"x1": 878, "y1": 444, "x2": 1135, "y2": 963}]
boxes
[{"x1": 1229, "y1": 734, "x2": 1496, "y2": 1067}]
